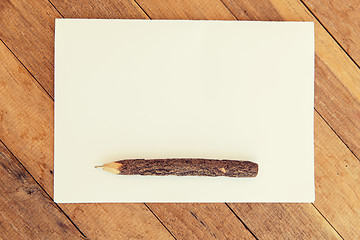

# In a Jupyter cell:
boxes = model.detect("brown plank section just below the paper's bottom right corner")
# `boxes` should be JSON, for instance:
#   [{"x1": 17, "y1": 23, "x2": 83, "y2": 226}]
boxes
[{"x1": 229, "y1": 203, "x2": 341, "y2": 240}]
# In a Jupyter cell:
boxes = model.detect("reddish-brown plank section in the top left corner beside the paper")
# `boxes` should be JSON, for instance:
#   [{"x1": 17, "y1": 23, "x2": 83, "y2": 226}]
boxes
[{"x1": 0, "y1": 0, "x2": 61, "y2": 96}]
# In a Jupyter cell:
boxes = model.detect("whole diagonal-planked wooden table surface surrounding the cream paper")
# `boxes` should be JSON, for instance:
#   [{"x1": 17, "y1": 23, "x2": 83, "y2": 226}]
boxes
[{"x1": 0, "y1": 0, "x2": 360, "y2": 239}]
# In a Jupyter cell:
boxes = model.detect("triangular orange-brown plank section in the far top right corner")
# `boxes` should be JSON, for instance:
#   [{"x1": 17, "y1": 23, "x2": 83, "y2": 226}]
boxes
[{"x1": 303, "y1": 0, "x2": 360, "y2": 65}]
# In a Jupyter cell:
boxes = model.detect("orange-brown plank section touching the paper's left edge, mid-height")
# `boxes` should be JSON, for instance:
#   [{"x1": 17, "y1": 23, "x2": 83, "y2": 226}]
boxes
[{"x1": 0, "y1": 38, "x2": 54, "y2": 191}]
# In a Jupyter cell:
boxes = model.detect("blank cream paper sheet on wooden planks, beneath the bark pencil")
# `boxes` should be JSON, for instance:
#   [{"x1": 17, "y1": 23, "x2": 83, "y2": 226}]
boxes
[{"x1": 54, "y1": 19, "x2": 315, "y2": 203}]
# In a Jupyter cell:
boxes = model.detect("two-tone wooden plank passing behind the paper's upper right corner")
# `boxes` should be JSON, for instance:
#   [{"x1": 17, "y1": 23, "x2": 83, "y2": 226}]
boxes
[{"x1": 223, "y1": 0, "x2": 360, "y2": 159}]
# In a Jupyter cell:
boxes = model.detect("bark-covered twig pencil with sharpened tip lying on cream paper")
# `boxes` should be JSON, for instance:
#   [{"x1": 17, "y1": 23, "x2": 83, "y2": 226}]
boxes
[{"x1": 99, "y1": 158, "x2": 258, "y2": 177}]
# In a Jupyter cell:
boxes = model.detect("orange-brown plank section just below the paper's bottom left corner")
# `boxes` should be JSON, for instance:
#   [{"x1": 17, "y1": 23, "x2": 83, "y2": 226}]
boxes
[{"x1": 59, "y1": 203, "x2": 174, "y2": 240}]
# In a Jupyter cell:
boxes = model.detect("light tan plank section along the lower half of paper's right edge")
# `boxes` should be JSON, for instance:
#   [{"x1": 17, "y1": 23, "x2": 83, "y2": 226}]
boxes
[{"x1": 315, "y1": 110, "x2": 360, "y2": 236}]
